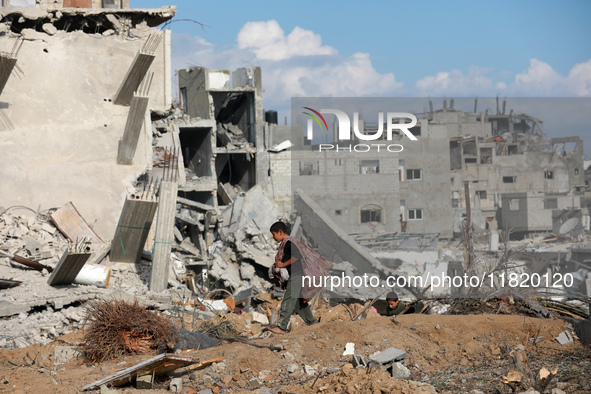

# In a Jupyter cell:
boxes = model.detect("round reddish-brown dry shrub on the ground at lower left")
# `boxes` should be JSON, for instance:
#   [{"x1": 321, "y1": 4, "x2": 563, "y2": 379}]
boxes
[{"x1": 82, "y1": 300, "x2": 177, "y2": 363}]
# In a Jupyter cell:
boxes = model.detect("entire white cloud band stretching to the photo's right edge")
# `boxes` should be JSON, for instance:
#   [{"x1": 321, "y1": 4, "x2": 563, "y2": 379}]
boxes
[{"x1": 172, "y1": 20, "x2": 591, "y2": 109}]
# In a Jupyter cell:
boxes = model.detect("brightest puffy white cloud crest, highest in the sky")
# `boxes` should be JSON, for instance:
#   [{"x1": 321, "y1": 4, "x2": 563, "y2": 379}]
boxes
[{"x1": 236, "y1": 20, "x2": 337, "y2": 60}]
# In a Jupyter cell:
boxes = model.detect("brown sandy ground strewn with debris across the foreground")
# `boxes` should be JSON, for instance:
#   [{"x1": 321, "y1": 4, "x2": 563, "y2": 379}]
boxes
[{"x1": 0, "y1": 311, "x2": 591, "y2": 394}]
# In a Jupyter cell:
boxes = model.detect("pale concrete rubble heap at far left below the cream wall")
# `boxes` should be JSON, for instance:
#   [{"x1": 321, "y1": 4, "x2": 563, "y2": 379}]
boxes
[{"x1": 0, "y1": 207, "x2": 161, "y2": 349}]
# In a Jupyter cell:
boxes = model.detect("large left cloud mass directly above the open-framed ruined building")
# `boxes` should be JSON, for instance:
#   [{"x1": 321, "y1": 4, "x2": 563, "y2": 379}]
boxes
[{"x1": 172, "y1": 20, "x2": 402, "y2": 109}]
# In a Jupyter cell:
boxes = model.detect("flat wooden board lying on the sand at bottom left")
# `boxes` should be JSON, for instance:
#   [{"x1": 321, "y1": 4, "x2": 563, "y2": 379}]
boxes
[{"x1": 82, "y1": 353, "x2": 199, "y2": 391}]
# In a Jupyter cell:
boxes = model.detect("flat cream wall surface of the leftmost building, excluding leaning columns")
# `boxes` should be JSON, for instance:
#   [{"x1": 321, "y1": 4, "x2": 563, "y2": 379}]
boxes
[{"x1": 0, "y1": 9, "x2": 175, "y2": 238}]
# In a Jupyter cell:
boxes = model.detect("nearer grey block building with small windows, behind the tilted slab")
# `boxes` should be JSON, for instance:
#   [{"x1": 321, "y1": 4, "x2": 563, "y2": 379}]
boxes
[{"x1": 267, "y1": 119, "x2": 452, "y2": 237}]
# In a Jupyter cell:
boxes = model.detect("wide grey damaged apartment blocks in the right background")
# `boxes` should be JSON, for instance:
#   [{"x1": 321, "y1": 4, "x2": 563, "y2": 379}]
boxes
[{"x1": 270, "y1": 100, "x2": 588, "y2": 238}]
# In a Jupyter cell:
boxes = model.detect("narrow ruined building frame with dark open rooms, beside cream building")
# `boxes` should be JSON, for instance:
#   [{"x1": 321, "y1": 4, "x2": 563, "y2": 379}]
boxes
[{"x1": 176, "y1": 67, "x2": 269, "y2": 205}]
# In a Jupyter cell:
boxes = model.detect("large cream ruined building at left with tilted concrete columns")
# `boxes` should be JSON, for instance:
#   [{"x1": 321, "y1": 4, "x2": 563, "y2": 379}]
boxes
[{"x1": 0, "y1": 0, "x2": 176, "y2": 238}]
